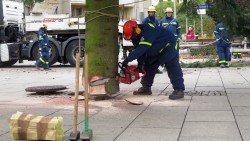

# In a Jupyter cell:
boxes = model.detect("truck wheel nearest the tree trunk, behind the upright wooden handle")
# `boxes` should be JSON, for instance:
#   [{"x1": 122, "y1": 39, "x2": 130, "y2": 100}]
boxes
[{"x1": 66, "y1": 40, "x2": 84, "y2": 66}]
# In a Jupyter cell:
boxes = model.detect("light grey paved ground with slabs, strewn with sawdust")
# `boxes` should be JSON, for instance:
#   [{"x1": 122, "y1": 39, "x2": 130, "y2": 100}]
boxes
[{"x1": 0, "y1": 65, "x2": 250, "y2": 141}]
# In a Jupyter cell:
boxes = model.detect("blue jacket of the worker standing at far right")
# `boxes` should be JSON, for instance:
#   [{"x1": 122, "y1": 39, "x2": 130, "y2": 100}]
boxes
[{"x1": 214, "y1": 23, "x2": 230, "y2": 46}]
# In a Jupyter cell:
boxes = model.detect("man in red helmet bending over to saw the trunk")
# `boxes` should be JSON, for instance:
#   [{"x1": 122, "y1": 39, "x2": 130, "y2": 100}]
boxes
[{"x1": 122, "y1": 20, "x2": 185, "y2": 99}]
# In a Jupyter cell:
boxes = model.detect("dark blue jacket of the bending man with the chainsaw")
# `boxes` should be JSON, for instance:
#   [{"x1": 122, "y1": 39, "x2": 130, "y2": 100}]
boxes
[{"x1": 128, "y1": 23, "x2": 178, "y2": 64}]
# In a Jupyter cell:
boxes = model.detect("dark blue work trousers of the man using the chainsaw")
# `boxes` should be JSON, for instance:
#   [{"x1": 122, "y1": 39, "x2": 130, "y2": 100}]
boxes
[{"x1": 141, "y1": 55, "x2": 185, "y2": 90}]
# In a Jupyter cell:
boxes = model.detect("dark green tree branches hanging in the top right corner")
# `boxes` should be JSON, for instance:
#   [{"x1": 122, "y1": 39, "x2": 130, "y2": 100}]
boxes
[{"x1": 183, "y1": 0, "x2": 250, "y2": 37}]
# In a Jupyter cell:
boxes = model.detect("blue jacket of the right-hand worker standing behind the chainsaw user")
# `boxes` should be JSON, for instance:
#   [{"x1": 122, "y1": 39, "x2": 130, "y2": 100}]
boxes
[{"x1": 160, "y1": 17, "x2": 182, "y2": 40}]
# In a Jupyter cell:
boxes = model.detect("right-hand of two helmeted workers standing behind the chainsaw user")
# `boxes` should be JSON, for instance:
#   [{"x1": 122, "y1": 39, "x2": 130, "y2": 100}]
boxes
[{"x1": 160, "y1": 7, "x2": 182, "y2": 48}]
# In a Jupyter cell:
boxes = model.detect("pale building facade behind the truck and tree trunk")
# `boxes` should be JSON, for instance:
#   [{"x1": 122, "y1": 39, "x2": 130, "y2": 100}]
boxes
[{"x1": 30, "y1": 0, "x2": 152, "y2": 21}]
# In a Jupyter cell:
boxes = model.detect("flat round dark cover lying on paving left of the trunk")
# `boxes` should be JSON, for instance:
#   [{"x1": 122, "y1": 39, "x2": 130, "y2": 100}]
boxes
[{"x1": 25, "y1": 85, "x2": 67, "y2": 93}]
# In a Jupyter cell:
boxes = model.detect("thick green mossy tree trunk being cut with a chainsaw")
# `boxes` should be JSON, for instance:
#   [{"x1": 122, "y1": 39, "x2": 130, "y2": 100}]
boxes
[{"x1": 85, "y1": 0, "x2": 119, "y2": 94}]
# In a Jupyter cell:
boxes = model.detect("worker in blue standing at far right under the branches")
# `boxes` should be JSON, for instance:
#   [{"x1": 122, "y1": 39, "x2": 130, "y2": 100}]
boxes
[{"x1": 214, "y1": 23, "x2": 231, "y2": 68}]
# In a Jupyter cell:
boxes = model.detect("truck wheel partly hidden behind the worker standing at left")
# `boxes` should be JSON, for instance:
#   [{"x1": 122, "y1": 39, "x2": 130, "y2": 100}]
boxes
[{"x1": 32, "y1": 42, "x2": 59, "y2": 65}]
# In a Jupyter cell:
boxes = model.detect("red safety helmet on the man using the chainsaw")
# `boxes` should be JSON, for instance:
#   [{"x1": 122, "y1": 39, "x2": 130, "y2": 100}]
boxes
[{"x1": 123, "y1": 20, "x2": 138, "y2": 40}]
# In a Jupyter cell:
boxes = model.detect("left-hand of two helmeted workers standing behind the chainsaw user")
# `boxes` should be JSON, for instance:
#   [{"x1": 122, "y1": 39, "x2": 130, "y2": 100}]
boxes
[{"x1": 142, "y1": 6, "x2": 162, "y2": 74}]
